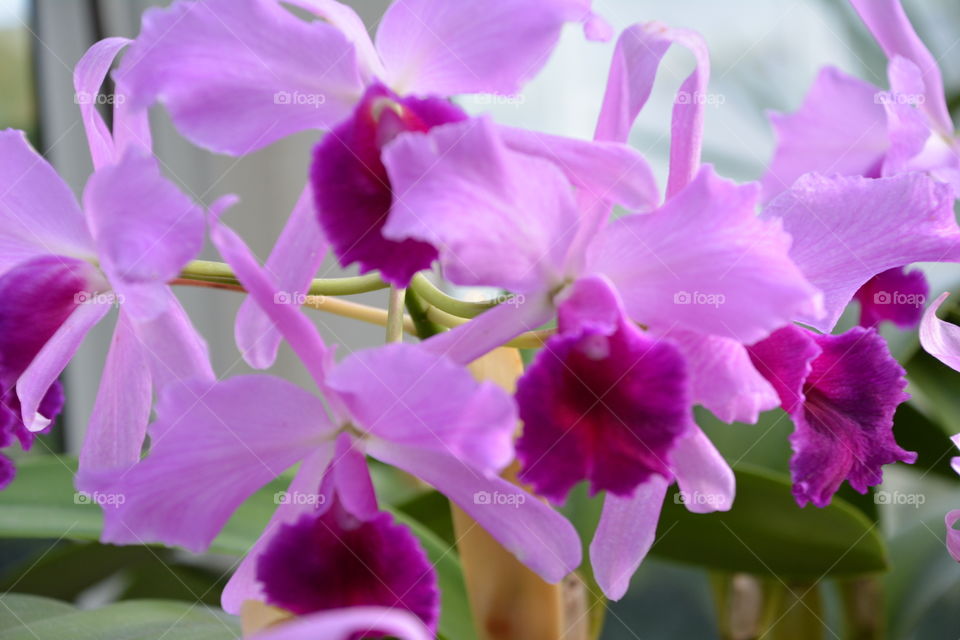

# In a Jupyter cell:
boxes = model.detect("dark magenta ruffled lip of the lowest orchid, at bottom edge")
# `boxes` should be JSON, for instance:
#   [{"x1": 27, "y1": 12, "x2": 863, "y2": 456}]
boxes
[{"x1": 257, "y1": 501, "x2": 440, "y2": 631}]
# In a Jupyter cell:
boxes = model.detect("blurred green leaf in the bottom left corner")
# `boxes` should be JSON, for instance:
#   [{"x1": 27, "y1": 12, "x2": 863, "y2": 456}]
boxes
[{"x1": 0, "y1": 594, "x2": 240, "y2": 640}]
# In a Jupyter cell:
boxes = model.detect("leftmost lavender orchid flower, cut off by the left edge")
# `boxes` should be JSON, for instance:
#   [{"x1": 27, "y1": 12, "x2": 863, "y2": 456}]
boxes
[{"x1": 0, "y1": 38, "x2": 213, "y2": 488}]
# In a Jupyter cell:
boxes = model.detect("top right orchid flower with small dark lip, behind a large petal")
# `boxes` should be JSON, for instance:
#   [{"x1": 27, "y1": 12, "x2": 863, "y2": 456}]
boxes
[{"x1": 763, "y1": 0, "x2": 960, "y2": 328}]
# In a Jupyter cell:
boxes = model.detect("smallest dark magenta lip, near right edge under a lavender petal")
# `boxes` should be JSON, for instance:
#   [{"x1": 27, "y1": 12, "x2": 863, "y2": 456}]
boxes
[{"x1": 853, "y1": 267, "x2": 930, "y2": 329}]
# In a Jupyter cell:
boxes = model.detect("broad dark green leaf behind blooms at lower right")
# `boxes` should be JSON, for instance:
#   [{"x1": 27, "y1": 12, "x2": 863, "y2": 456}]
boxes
[{"x1": 651, "y1": 467, "x2": 887, "y2": 580}]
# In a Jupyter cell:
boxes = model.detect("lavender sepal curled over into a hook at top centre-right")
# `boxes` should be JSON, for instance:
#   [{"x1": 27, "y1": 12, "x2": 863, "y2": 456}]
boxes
[{"x1": 596, "y1": 22, "x2": 710, "y2": 198}]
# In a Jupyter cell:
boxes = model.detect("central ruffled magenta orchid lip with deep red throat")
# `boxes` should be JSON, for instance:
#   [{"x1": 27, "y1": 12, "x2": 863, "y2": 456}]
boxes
[{"x1": 516, "y1": 279, "x2": 691, "y2": 503}]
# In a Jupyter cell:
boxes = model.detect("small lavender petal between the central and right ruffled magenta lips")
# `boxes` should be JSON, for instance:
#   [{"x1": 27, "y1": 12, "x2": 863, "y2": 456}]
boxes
[{"x1": 665, "y1": 330, "x2": 780, "y2": 424}]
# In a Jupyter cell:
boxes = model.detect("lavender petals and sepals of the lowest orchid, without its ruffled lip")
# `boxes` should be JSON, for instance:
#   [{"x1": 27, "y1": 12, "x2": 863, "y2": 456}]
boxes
[{"x1": 103, "y1": 208, "x2": 580, "y2": 613}]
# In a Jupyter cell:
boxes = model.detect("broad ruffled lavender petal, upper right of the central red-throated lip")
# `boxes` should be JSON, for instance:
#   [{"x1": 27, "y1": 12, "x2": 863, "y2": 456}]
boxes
[{"x1": 591, "y1": 166, "x2": 820, "y2": 343}]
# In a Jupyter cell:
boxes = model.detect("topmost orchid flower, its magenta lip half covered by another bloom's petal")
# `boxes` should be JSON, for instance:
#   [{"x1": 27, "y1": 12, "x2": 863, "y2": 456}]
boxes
[{"x1": 109, "y1": 0, "x2": 656, "y2": 369}]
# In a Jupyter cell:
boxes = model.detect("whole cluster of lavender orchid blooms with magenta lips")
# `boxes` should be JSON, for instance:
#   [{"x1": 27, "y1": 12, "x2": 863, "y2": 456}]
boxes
[{"x1": 0, "y1": 0, "x2": 960, "y2": 639}]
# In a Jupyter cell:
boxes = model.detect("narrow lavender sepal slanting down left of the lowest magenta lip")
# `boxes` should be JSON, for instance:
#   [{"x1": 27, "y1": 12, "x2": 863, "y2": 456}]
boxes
[{"x1": 220, "y1": 442, "x2": 333, "y2": 615}]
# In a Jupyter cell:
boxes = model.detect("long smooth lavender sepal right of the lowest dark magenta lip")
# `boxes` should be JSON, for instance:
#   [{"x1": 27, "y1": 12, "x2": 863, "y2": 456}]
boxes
[{"x1": 367, "y1": 441, "x2": 581, "y2": 583}]
